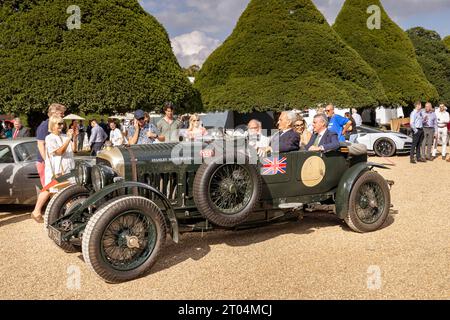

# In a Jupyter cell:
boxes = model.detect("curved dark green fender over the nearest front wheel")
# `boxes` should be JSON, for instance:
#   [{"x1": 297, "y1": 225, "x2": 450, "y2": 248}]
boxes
[{"x1": 66, "y1": 181, "x2": 179, "y2": 243}]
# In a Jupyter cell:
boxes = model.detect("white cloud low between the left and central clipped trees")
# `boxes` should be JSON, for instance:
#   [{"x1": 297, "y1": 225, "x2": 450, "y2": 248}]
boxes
[{"x1": 171, "y1": 31, "x2": 220, "y2": 67}]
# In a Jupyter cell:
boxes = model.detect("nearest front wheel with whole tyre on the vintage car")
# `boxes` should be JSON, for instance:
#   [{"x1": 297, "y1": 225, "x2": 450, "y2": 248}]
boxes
[{"x1": 82, "y1": 196, "x2": 166, "y2": 283}]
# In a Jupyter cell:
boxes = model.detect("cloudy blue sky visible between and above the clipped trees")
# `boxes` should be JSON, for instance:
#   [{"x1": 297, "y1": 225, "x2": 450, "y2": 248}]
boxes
[{"x1": 140, "y1": 0, "x2": 450, "y2": 66}]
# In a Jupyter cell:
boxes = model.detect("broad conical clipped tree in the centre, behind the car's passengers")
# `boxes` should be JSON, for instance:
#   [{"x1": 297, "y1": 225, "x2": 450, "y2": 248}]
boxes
[{"x1": 195, "y1": 0, "x2": 386, "y2": 112}]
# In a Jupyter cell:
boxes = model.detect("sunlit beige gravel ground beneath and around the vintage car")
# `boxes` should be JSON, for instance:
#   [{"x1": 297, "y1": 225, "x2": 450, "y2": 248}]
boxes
[{"x1": 0, "y1": 157, "x2": 450, "y2": 299}]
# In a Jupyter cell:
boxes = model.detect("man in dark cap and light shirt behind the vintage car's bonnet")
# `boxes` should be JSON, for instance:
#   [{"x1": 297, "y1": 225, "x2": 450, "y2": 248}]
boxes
[{"x1": 128, "y1": 110, "x2": 164, "y2": 145}]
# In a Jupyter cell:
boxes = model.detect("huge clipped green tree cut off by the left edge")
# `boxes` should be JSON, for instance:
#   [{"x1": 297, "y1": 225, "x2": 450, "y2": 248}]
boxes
[{"x1": 0, "y1": 0, "x2": 200, "y2": 113}]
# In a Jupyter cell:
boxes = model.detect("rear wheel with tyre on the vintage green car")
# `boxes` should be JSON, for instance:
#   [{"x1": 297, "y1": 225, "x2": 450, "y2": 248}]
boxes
[{"x1": 344, "y1": 171, "x2": 391, "y2": 233}]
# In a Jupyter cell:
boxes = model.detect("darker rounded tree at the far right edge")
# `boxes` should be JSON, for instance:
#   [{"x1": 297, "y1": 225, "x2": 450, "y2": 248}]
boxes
[{"x1": 406, "y1": 27, "x2": 450, "y2": 105}]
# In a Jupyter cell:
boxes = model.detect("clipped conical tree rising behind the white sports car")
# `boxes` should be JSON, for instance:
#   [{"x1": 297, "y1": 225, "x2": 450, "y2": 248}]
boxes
[{"x1": 334, "y1": 0, "x2": 438, "y2": 106}]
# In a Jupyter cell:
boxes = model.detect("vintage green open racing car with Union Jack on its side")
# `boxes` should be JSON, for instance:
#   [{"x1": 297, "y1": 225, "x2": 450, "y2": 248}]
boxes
[{"x1": 45, "y1": 139, "x2": 393, "y2": 283}]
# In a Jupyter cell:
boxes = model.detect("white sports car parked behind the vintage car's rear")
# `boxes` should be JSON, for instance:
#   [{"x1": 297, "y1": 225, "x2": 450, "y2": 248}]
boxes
[{"x1": 351, "y1": 125, "x2": 412, "y2": 157}]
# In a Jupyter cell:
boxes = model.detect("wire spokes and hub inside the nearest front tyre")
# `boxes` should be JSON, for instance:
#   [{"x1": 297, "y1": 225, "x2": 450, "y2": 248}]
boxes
[{"x1": 101, "y1": 211, "x2": 157, "y2": 271}]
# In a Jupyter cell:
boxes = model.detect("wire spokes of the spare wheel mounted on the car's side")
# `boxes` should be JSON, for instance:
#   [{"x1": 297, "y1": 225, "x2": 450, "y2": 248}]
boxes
[{"x1": 209, "y1": 164, "x2": 254, "y2": 215}]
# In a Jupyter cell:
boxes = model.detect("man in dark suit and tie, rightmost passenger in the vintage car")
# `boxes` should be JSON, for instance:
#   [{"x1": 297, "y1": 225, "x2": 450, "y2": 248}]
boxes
[{"x1": 306, "y1": 114, "x2": 340, "y2": 152}]
